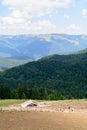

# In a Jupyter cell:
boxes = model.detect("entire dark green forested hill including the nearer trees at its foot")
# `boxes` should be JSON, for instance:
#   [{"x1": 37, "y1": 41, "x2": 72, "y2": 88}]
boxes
[{"x1": 0, "y1": 53, "x2": 87, "y2": 100}]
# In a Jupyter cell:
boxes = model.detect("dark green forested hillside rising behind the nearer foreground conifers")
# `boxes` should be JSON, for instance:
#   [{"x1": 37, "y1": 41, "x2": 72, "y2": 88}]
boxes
[{"x1": 0, "y1": 53, "x2": 87, "y2": 98}]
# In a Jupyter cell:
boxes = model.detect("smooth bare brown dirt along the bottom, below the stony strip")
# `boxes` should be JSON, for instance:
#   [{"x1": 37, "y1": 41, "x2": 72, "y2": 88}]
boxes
[{"x1": 0, "y1": 111, "x2": 87, "y2": 130}]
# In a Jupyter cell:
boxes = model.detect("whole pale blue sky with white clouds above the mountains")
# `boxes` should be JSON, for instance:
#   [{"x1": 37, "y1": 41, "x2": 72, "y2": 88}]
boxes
[{"x1": 0, "y1": 0, "x2": 87, "y2": 35}]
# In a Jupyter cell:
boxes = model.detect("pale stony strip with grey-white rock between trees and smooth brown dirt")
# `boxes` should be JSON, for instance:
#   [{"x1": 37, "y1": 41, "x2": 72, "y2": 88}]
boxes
[{"x1": 0, "y1": 100, "x2": 87, "y2": 113}]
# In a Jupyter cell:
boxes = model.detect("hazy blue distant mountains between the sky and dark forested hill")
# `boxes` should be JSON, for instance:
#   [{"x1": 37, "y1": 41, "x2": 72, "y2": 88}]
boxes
[{"x1": 0, "y1": 34, "x2": 87, "y2": 69}]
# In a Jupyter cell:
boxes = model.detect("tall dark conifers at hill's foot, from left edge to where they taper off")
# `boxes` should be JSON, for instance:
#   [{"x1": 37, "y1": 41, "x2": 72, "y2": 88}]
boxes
[{"x1": 0, "y1": 84, "x2": 66, "y2": 100}]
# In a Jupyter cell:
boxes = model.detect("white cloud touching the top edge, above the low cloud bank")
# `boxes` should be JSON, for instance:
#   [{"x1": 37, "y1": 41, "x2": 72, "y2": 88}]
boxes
[{"x1": 3, "y1": 0, "x2": 71, "y2": 18}]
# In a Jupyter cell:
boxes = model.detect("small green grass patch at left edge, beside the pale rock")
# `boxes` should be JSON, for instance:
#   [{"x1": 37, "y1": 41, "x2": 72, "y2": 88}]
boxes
[{"x1": 0, "y1": 99, "x2": 25, "y2": 107}]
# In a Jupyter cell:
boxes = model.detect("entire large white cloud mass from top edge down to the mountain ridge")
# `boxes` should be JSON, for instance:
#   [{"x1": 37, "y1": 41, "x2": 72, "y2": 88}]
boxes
[{"x1": 0, "y1": 0, "x2": 72, "y2": 34}]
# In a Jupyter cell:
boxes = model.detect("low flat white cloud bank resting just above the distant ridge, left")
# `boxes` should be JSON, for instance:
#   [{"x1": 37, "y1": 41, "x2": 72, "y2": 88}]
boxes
[{"x1": 0, "y1": 19, "x2": 56, "y2": 35}]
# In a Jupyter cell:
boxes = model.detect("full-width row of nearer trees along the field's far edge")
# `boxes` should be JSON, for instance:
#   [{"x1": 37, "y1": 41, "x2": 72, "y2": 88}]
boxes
[{"x1": 0, "y1": 84, "x2": 87, "y2": 100}]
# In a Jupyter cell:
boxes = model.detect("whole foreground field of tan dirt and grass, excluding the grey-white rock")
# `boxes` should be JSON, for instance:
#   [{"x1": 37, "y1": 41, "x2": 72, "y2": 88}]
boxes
[{"x1": 0, "y1": 100, "x2": 87, "y2": 130}]
